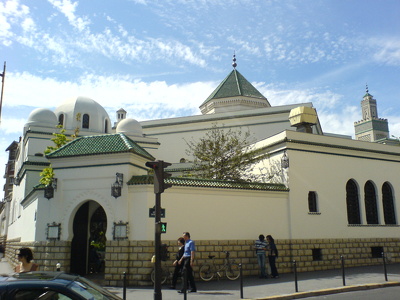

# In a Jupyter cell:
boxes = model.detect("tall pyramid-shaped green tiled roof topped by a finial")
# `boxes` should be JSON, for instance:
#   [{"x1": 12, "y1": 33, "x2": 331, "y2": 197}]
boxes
[{"x1": 202, "y1": 69, "x2": 268, "y2": 105}]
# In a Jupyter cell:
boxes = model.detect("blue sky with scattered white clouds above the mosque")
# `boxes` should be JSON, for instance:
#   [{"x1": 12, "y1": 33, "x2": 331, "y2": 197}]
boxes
[{"x1": 0, "y1": 0, "x2": 400, "y2": 183}]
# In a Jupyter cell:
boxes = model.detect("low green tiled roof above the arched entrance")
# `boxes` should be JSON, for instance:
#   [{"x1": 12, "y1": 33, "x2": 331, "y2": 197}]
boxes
[{"x1": 46, "y1": 133, "x2": 154, "y2": 160}]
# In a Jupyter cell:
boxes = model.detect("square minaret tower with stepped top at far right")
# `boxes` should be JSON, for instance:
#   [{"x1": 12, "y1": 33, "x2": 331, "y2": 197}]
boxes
[{"x1": 354, "y1": 85, "x2": 389, "y2": 142}]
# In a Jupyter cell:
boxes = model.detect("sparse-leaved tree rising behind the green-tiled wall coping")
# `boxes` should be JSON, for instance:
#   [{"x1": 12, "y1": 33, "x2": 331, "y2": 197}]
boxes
[{"x1": 185, "y1": 124, "x2": 268, "y2": 181}]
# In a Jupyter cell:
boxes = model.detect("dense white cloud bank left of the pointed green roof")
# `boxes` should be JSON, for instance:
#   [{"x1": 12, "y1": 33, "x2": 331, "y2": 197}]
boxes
[{"x1": 3, "y1": 72, "x2": 218, "y2": 117}]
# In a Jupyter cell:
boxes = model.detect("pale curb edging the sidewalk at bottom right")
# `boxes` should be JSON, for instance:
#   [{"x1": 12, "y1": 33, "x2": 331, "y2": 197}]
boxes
[{"x1": 247, "y1": 281, "x2": 400, "y2": 300}]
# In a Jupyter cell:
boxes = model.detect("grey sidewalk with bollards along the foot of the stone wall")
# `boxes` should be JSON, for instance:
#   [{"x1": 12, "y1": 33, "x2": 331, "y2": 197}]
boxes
[{"x1": 0, "y1": 259, "x2": 400, "y2": 300}]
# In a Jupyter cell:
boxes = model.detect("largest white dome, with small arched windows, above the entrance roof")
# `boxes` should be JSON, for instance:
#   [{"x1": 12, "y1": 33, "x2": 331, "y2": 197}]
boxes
[{"x1": 54, "y1": 97, "x2": 111, "y2": 133}]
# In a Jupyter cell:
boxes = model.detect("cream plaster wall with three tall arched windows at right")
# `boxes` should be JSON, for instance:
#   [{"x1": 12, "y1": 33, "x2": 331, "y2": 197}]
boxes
[{"x1": 288, "y1": 131, "x2": 400, "y2": 238}]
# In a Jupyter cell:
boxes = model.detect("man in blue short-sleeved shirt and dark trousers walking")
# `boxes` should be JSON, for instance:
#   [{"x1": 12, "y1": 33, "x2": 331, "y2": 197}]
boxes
[{"x1": 178, "y1": 232, "x2": 197, "y2": 293}]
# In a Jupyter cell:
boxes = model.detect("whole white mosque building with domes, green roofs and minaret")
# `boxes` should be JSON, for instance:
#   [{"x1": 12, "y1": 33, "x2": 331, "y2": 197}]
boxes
[{"x1": 0, "y1": 57, "x2": 400, "y2": 285}]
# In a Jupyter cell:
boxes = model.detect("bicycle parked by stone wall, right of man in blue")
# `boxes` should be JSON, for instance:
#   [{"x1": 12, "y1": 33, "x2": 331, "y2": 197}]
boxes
[{"x1": 200, "y1": 251, "x2": 240, "y2": 281}]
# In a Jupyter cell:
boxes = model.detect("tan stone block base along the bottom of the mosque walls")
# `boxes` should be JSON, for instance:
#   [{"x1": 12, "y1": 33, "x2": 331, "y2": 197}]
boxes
[{"x1": 6, "y1": 238, "x2": 400, "y2": 286}]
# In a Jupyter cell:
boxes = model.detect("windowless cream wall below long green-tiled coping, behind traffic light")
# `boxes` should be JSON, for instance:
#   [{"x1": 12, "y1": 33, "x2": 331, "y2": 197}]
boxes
[{"x1": 132, "y1": 186, "x2": 288, "y2": 240}]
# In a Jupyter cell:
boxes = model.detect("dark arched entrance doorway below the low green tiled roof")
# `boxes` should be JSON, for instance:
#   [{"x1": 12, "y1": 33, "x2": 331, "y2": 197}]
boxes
[{"x1": 71, "y1": 201, "x2": 107, "y2": 275}]
